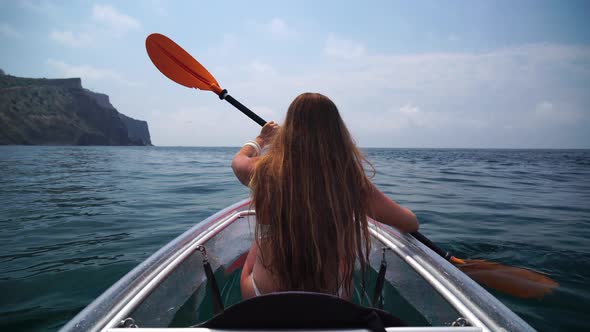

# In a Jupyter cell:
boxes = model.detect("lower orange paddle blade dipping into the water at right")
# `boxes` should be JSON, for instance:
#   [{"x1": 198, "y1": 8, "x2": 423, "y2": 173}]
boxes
[{"x1": 456, "y1": 259, "x2": 559, "y2": 299}]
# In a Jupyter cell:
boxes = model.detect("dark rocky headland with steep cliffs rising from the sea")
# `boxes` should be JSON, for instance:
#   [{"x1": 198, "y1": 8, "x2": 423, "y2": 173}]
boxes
[{"x1": 0, "y1": 71, "x2": 151, "y2": 145}]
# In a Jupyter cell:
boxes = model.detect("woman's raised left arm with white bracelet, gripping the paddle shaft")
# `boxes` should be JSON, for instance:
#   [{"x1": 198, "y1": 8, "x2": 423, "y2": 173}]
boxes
[{"x1": 231, "y1": 121, "x2": 279, "y2": 186}]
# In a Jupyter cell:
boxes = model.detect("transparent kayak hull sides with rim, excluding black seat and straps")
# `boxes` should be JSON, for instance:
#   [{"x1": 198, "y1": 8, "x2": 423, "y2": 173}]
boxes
[{"x1": 61, "y1": 200, "x2": 534, "y2": 332}]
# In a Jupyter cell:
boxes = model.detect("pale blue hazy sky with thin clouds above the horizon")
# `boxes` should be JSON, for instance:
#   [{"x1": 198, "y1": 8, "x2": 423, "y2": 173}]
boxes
[{"x1": 0, "y1": 0, "x2": 590, "y2": 148}]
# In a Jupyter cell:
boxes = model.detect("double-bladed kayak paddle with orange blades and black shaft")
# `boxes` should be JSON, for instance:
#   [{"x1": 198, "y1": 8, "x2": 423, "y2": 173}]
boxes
[{"x1": 145, "y1": 33, "x2": 558, "y2": 298}]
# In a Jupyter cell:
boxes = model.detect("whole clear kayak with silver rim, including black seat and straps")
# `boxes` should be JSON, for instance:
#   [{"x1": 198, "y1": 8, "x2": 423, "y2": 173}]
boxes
[{"x1": 61, "y1": 199, "x2": 534, "y2": 332}]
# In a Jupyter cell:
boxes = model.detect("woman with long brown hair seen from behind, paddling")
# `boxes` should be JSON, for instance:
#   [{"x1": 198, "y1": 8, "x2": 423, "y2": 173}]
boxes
[{"x1": 232, "y1": 93, "x2": 418, "y2": 299}]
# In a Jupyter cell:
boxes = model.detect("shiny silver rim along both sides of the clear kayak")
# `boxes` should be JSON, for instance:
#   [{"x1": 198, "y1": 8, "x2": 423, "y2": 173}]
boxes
[{"x1": 62, "y1": 199, "x2": 533, "y2": 331}]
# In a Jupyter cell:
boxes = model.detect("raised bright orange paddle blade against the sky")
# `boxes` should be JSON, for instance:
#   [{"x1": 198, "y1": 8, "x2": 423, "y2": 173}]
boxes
[{"x1": 145, "y1": 33, "x2": 222, "y2": 95}]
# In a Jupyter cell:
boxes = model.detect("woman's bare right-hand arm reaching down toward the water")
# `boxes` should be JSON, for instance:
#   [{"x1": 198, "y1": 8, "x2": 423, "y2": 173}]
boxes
[{"x1": 369, "y1": 184, "x2": 419, "y2": 233}]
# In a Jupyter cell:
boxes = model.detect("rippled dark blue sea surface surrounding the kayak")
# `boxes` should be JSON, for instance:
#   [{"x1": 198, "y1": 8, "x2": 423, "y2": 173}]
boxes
[{"x1": 0, "y1": 147, "x2": 590, "y2": 331}]
